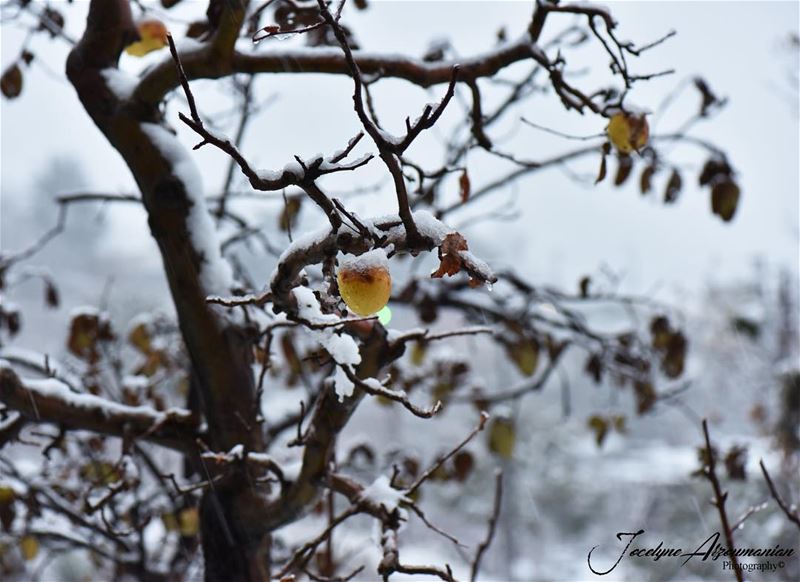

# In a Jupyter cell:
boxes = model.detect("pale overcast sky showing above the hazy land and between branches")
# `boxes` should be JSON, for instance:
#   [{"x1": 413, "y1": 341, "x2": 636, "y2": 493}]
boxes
[{"x1": 0, "y1": 1, "x2": 799, "y2": 320}]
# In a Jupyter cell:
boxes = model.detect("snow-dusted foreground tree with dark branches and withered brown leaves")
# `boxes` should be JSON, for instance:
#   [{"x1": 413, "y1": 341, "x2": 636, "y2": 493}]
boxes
[{"x1": 0, "y1": 0, "x2": 796, "y2": 580}]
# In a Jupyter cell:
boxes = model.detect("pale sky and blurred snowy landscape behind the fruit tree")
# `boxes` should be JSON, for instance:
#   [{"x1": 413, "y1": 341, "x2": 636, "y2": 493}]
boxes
[{"x1": 0, "y1": 1, "x2": 800, "y2": 581}]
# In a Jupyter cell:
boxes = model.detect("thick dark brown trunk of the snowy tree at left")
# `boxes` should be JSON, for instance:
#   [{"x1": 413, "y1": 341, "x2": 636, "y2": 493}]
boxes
[{"x1": 67, "y1": 0, "x2": 270, "y2": 581}]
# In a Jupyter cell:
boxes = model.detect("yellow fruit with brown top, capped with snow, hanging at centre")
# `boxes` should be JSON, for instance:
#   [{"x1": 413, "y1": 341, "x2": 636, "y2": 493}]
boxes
[{"x1": 337, "y1": 249, "x2": 392, "y2": 317}]
